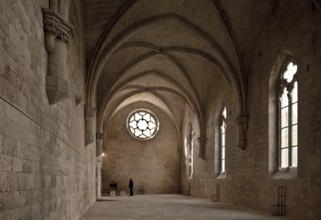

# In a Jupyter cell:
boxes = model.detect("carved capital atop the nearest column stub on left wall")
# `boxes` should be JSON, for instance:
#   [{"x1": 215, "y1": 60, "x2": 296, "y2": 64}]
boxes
[{"x1": 42, "y1": 8, "x2": 73, "y2": 44}]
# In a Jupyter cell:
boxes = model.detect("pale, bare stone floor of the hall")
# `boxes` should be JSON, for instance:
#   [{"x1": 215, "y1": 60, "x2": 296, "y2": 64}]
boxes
[{"x1": 81, "y1": 195, "x2": 285, "y2": 220}]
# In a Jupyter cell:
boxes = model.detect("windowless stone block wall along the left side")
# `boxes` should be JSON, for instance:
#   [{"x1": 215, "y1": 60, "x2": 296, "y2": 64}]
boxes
[{"x1": 0, "y1": 0, "x2": 95, "y2": 220}]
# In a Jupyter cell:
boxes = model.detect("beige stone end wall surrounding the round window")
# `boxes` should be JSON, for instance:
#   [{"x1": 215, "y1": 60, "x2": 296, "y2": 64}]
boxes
[{"x1": 102, "y1": 102, "x2": 180, "y2": 194}]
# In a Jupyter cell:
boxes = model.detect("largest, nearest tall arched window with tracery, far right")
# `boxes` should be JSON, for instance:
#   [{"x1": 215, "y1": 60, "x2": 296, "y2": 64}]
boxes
[{"x1": 279, "y1": 62, "x2": 298, "y2": 168}]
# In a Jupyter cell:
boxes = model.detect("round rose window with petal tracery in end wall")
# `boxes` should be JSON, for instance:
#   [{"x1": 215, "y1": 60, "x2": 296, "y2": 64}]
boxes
[{"x1": 127, "y1": 109, "x2": 159, "y2": 140}]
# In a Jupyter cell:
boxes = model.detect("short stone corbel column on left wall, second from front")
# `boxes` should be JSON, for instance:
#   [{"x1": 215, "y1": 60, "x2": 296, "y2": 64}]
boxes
[{"x1": 85, "y1": 105, "x2": 96, "y2": 145}]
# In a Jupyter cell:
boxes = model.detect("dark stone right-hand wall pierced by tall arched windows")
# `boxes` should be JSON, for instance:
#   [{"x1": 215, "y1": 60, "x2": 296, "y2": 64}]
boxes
[{"x1": 184, "y1": 1, "x2": 321, "y2": 220}]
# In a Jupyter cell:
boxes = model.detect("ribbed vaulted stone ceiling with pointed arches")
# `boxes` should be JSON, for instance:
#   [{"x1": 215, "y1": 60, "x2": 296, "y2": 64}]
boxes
[{"x1": 84, "y1": 0, "x2": 275, "y2": 135}]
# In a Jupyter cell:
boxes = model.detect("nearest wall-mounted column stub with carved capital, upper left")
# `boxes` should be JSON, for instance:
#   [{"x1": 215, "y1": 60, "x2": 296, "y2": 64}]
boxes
[{"x1": 42, "y1": 8, "x2": 73, "y2": 104}]
